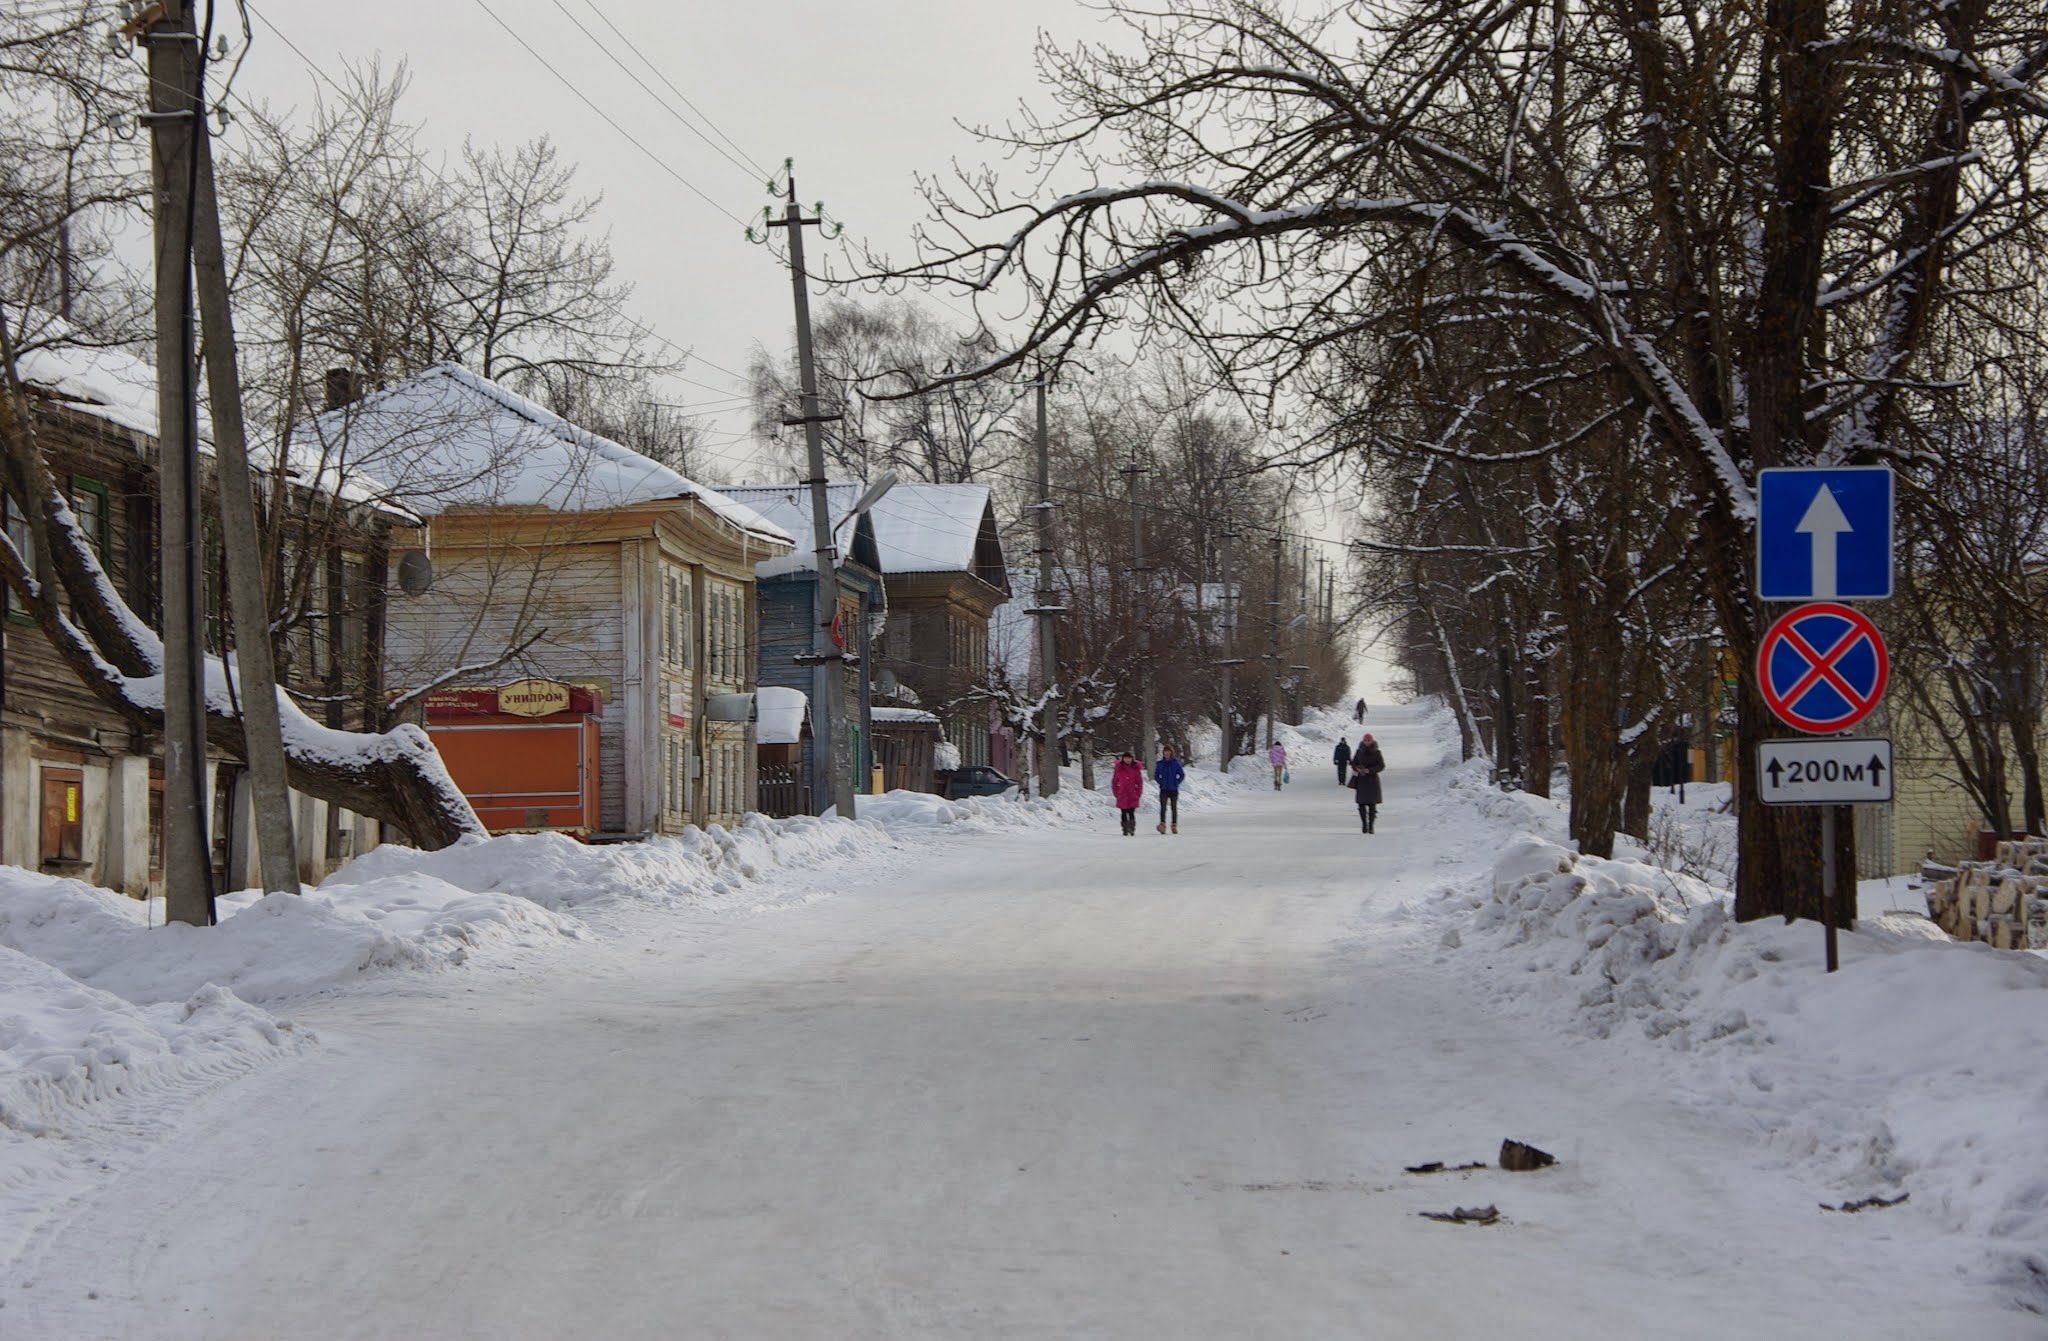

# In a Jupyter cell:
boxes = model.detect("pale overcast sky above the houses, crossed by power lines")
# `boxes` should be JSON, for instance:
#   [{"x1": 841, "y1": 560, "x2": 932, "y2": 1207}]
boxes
[{"x1": 225, "y1": 0, "x2": 1104, "y2": 479}]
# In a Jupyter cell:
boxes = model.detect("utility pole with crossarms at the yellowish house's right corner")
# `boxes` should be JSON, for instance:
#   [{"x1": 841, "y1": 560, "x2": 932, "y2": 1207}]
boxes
[{"x1": 766, "y1": 172, "x2": 854, "y2": 819}]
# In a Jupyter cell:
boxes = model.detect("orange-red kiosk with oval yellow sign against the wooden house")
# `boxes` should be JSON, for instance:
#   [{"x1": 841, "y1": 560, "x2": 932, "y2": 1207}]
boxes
[{"x1": 426, "y1": 680, "x2": 604, "y2": 837}]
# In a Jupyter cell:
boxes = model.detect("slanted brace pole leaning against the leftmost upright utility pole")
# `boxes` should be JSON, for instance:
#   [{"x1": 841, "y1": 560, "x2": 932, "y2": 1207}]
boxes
[{"x1": 193, "y1": 97, "x2": 299, "y2": 895}]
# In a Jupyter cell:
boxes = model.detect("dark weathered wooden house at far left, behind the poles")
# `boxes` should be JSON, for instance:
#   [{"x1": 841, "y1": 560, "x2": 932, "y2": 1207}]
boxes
[{"x1": 0, "y1": 346, "x2": 403, "y2": 897}]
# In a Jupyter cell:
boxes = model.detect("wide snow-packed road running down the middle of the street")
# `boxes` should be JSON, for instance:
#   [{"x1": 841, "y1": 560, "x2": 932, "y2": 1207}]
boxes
[{"x1": 12, "y1": 708, "x2": 2040, "y2": 1341}]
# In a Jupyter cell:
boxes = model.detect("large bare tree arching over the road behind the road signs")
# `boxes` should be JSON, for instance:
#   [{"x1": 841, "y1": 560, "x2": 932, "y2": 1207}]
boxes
[{"x1": 860, "y1": 0, "x2": 2048, "y2": 917}]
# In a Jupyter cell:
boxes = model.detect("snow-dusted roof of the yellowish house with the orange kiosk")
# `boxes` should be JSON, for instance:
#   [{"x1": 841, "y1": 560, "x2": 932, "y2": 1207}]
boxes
[{"x1": 301, "y1": 362, "x2": 795, "y2": 545}]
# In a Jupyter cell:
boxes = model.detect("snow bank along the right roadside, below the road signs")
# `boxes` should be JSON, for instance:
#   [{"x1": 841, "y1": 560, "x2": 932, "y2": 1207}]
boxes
[{"x1": 1466, "y1": 835, "x2": 2048, "y2": 1306}]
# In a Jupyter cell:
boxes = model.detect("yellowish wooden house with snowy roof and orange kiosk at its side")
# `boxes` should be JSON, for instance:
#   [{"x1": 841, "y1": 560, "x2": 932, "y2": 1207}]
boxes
[{"x1": 307, "y1": 364, "x2": 793, "y2": 837}]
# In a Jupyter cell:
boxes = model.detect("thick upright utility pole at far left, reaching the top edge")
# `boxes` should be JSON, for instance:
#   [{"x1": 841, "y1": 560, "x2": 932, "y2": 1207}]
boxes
[{"x1": 135, "y1": 0, "x2": 213, "y2": 927}]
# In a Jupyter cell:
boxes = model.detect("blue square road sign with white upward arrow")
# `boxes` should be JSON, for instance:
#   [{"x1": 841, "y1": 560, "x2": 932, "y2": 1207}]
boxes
[{"x1": 1757, "y1": 465, "x2": 1892, "y2": 600}]
